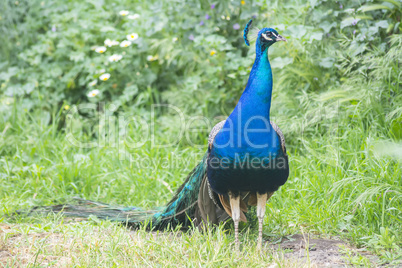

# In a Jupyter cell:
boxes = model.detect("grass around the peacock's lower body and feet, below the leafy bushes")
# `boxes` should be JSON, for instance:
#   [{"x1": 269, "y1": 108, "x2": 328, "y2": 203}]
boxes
[{"x1": 0, "y1": 94, "x2": 402, "y2": 267}]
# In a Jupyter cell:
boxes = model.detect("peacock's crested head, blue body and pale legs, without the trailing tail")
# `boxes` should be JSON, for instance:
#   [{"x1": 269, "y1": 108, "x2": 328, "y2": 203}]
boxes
[{"x1": 207, "y1": 21, "x2": 289, "y2": 248}]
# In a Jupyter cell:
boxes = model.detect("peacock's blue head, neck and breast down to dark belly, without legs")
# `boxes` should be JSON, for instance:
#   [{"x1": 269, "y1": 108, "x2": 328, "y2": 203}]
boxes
[{"x1": 207, "y1": 23, "x2": 289, "y2": 197}]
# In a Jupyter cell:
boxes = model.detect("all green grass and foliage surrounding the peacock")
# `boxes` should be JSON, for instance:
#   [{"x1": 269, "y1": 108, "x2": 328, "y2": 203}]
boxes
[{"x1": 0, "y1": 0, "x2": 402, "y2": 267}]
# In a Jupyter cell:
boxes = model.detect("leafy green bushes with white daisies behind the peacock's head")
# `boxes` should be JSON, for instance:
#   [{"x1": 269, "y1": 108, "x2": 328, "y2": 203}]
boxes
[{"x1": 0, "y1": 0, "x2": 402, "y2": 114}]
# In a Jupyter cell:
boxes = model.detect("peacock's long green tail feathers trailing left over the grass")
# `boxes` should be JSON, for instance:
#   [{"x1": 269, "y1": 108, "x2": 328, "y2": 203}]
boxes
[{"x1": 17, "y1": 151, "x2": 207, "y2": 230}]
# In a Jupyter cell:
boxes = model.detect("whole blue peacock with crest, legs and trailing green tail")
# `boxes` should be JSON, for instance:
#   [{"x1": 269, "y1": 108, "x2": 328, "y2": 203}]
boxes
[{"x1": 23, "y1": 20, "x2": 289, "y2": 248}]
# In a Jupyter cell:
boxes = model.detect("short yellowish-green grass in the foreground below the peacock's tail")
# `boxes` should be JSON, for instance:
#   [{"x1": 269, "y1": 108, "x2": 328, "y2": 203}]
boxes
[{"x1": 0, "y1": 219, "x2": 307, "y2": 267}]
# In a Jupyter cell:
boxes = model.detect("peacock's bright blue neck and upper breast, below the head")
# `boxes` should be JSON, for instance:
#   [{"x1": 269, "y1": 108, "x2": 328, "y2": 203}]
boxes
[{"x1": 215, "y1": 42, "x2": 279, "y2": 156}]
